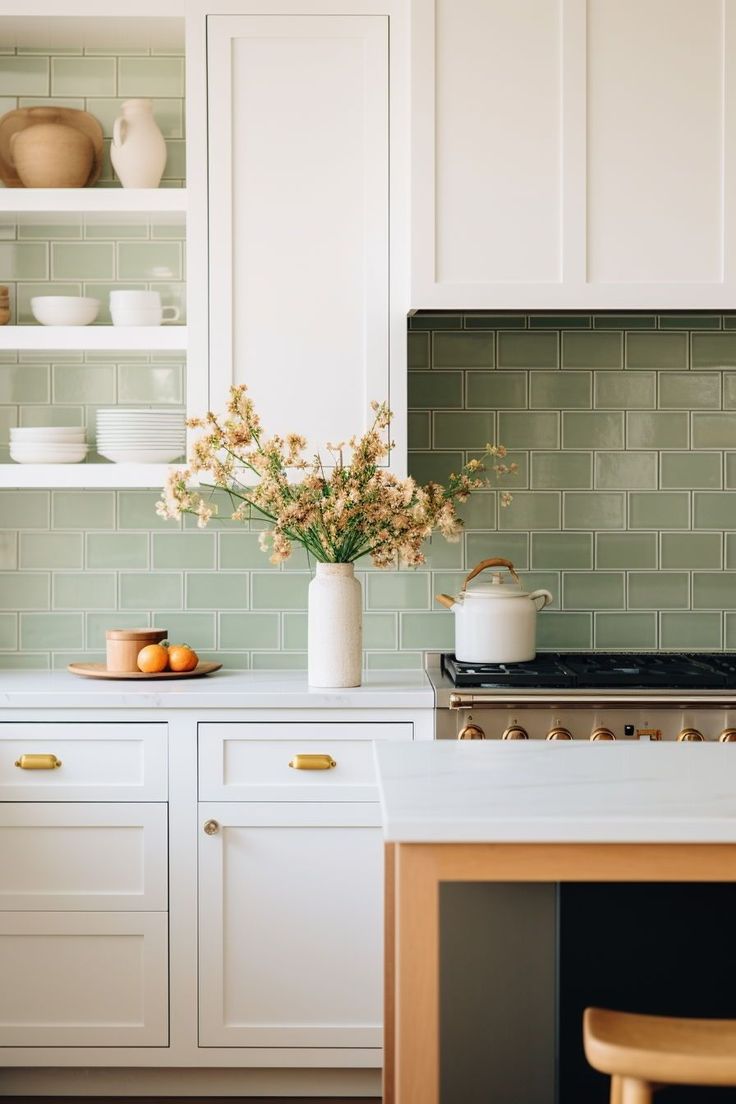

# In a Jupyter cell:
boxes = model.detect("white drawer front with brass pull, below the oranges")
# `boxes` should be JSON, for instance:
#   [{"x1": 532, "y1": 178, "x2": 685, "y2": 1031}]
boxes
[{"x1": 0, "y1": 721, "x2": 167, "y2": 802}]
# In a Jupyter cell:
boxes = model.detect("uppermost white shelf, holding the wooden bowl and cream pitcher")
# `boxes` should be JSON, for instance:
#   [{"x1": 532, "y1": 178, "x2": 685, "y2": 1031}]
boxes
[{"x1": 0, "y1": 188, "x2": 186, "y2": 215}]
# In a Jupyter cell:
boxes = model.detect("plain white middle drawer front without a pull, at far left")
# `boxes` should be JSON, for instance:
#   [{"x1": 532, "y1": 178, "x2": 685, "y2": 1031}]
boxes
[{"x1": 0, "y1": 802, "x2": 167, "y2": 912}]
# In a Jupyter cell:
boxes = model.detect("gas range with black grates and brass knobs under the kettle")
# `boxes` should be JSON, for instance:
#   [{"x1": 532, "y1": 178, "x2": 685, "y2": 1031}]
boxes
[{"x1": 427, "y1": 652, "x2": 736, "y2": 743}]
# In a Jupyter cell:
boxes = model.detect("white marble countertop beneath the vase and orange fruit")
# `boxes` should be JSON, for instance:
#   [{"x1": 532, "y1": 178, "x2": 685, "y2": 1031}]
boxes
[{"x1": 0, "y1": 670, "x2": 435, "y2": 711}]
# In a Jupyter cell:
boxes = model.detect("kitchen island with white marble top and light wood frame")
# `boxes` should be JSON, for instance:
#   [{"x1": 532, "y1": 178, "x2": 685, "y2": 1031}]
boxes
[{"x1": 375, "y1": 742, "x2": 736, "y2": 1104}]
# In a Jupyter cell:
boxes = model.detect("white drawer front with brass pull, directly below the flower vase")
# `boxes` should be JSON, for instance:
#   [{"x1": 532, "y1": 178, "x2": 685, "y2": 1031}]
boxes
[{"x1": 199, "y1": 721, "x2": 414, "y2": 802}]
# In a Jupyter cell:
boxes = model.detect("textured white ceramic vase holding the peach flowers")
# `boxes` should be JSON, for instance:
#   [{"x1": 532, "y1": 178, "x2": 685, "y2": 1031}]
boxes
[{"x1": 308, "y1": 563, "x2": 363, "y2": 687}]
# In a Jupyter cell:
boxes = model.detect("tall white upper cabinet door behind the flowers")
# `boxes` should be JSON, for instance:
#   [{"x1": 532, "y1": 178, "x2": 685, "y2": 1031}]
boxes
[{"x1": 207, "y1": 12, "x2": 407, "y2": 467}]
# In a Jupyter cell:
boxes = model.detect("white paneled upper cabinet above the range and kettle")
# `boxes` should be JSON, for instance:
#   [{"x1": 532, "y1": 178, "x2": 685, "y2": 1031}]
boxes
[{"x1": 412, "y1": 0, "x2": 736, "y2": 309}]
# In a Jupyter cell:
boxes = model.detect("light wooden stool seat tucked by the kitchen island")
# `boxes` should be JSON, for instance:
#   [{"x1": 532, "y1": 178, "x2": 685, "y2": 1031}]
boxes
[{"x1": 583, "y1": 1008, "x2": 736, "y2": 1104}]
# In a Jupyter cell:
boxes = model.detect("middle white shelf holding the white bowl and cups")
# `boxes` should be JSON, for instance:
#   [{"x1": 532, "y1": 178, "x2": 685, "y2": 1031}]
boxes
[{"x1": 0, "y1": 326, "x2": 186, "y2": 352}]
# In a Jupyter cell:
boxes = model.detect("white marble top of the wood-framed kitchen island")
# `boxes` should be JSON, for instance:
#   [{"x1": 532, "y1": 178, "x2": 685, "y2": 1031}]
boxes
[{"x1": 375, "y1": 741, "x2": 736, "y2": 843}]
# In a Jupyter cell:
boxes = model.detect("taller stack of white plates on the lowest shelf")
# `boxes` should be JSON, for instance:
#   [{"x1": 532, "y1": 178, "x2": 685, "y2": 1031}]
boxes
[{"x1": 97, "y1": 406, "x2": 186, "y2": 464}]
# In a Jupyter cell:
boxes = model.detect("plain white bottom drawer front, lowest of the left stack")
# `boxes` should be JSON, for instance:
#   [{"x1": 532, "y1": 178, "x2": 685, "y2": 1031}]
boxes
[{"x1": 0, "y1": 912, "x2": 169, "y2": 1047}]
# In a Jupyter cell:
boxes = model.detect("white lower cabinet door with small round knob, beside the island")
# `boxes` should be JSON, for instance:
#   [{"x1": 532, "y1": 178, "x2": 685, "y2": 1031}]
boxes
[{"x1": 200, "y1": 802, "x2": 383, "y2": 1048}]
